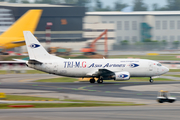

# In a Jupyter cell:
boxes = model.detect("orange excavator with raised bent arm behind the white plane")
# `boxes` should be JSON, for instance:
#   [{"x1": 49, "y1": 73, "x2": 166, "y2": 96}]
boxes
[{"x1": 81, "y1": 30, "x2": 108, "y2": 55}]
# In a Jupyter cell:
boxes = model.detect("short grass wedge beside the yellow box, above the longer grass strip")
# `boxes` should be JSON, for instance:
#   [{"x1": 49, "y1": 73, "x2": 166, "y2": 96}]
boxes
[{"x1": 6, "y1": 95, "x2": 59, "y2": 101}]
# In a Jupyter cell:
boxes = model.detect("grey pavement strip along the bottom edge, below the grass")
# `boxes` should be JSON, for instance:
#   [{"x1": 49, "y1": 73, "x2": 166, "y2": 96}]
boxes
[{"x1": 0, "y1": 104, "x2": 180, "y2": 120}]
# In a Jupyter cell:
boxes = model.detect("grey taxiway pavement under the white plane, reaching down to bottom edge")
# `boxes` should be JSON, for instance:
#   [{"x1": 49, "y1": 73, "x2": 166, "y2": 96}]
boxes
[{"x1": 0, "y1": 74, "x2": 180, "y2": 120}]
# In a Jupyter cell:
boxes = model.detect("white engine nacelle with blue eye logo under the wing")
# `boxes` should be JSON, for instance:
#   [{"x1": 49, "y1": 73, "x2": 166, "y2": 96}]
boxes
[{"x1": 114, "y1": 72, "x2": 130, "y2": 81}]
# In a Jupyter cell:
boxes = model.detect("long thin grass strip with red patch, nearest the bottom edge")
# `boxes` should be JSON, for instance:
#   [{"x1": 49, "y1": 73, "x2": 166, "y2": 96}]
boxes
[{"x1": 0, "y1": 103, "x2": 145, "y2": 109}]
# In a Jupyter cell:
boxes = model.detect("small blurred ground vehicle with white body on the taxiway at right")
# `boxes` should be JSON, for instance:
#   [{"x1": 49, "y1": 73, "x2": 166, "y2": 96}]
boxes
[{"x1": 157, "y1": 90, "x2": 176, "y2": 103}]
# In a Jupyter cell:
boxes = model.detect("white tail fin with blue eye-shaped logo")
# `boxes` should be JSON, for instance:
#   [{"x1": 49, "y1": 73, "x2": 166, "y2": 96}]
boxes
[{"x1": 23, "y1": 31, "x2": 63, "y2": 61}]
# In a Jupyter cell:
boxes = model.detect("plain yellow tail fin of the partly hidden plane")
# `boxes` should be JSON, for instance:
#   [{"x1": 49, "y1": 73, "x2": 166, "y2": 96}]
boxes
[{"x1": 0, "y1": 9, "x2": 42, "y2": 37}]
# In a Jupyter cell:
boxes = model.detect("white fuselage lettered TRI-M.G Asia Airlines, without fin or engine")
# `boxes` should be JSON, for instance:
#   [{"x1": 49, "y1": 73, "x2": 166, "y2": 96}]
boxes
[{"x1": 27, "y1": 59, "x2": 169, "y2": 77}]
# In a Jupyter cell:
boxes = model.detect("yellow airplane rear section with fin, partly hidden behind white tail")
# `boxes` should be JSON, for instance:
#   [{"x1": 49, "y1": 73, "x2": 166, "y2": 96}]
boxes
[{"x1": 0, "y1": 9, "x2": 42, "y2": 50}]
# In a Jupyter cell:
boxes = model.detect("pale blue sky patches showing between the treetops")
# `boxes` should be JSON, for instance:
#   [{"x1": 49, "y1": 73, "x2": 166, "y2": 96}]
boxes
[{"x1": 93, "y1": 0, "x2": 167, "y2": 10}]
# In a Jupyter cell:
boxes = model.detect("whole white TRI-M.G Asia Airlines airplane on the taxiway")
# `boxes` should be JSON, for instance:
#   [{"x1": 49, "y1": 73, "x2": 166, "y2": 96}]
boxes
[{"x1": 23, "y1": 31, "x2": 169, "y2": 83}]
